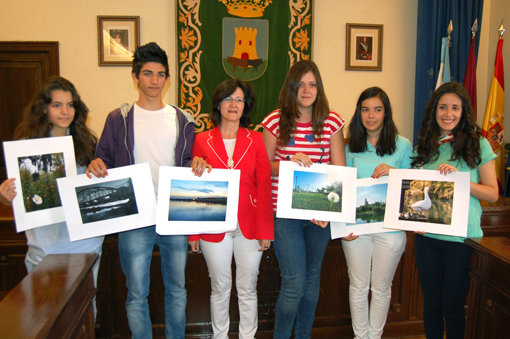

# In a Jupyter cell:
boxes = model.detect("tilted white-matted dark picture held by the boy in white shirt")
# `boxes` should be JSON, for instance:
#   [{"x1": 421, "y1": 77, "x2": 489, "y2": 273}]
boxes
[{"x1": 57, "y1": 163, "x2": 156, "y2": 241}]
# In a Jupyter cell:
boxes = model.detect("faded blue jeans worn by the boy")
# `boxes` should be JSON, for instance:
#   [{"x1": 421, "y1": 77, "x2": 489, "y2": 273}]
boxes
[{"x1": 119, "y1": 226, "x2": 188, "y2": 339}]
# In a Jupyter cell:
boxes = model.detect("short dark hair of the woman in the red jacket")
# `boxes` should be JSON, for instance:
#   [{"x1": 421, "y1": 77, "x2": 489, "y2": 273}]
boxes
[{"x1": 211, "y1": 79, "x2": 255, "y2": 127}]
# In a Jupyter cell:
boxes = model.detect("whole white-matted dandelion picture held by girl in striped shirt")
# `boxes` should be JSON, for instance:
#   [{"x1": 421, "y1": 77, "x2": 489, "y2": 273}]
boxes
[{"x1": 276, "y1": 161, "x2": 357, "y2": 222}]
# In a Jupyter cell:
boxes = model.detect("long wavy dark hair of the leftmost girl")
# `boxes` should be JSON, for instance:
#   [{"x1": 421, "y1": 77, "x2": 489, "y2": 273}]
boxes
[{"x1": 14, "y1": 76, "x2": 97, "y2": 166}]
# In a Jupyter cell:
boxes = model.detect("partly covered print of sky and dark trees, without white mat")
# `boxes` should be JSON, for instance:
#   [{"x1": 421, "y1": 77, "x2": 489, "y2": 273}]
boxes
[{"x1": 356, "y1": 183, "x2": 388, "y2": 224}]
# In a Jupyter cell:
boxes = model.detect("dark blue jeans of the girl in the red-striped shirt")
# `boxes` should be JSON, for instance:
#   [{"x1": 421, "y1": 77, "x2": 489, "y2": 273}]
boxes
[{"x1": 274, "y1": 218, "x2": 331, "y2": 339}]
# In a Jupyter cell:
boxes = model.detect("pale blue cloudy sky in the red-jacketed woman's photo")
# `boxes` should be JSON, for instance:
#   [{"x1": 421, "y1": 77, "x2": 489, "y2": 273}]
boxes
[{"x1": 170, "y1": 179, "x2": 228, "y2": 198}]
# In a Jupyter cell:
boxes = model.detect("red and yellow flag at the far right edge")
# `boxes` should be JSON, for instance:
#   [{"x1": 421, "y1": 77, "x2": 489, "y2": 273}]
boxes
[{"x1": 482, "y1": 37, "x2": 505, "y2": 193}]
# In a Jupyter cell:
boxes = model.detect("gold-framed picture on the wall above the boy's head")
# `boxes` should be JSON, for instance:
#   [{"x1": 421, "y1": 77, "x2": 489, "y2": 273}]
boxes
[{"x1": 97, "y1": 15, "x2": 140, "y2": 66}]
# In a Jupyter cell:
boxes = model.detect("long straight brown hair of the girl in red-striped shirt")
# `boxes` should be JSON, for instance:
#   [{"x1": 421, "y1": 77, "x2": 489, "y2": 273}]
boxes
[{"x1": 278, "y1": 60, "x2": 329, "y2": 145}]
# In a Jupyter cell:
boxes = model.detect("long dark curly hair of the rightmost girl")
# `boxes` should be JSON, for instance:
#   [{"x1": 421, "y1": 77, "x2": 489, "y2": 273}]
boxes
[{"x1": 411, "y1": 82, "x2": 482, "y2": 168}]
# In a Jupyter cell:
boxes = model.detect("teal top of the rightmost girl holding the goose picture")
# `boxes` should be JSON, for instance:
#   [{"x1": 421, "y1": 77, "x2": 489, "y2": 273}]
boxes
[{"x1": 414, "y1": 138, "x2": 497, "y2": 242}]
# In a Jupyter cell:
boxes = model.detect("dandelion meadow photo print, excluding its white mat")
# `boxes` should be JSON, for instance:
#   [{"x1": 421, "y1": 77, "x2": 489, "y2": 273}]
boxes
[{"x1": 292, "y1": 171, "x2": 342, "y2": 212}]
